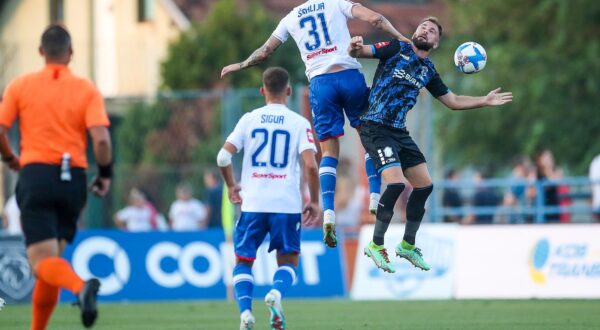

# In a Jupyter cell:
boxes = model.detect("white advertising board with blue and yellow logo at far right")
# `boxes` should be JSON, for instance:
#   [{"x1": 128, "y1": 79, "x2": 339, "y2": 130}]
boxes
[{"x1": 456, "y1": 225, "x2": 600, "y2": 298}]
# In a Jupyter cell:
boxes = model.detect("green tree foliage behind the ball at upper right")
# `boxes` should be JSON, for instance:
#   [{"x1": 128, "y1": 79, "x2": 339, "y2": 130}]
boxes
[{"x1": 436, "y1": 0, "x2": 600, "y2": 175}]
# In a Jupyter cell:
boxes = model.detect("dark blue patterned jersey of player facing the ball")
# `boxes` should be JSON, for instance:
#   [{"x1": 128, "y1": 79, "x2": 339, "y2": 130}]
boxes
[{"x1": 361, "y1": 40, "x2": 449, "y2": 128}]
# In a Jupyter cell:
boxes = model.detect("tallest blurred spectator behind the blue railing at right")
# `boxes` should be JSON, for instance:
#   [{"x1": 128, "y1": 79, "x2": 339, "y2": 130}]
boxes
[{"x1": 535, "y1": 149, "x2": 560, "y2": 223}]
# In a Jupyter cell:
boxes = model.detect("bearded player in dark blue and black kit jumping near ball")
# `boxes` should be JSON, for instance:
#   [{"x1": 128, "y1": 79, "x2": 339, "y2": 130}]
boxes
[{"x1": 348, "y1": 17, "x2": 512, "y2": 273}]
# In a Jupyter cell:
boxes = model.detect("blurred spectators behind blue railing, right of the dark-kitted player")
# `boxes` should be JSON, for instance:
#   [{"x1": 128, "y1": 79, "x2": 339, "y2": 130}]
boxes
[{"x1": 442, "y1": 149, "x2": 600, "y2": 224}]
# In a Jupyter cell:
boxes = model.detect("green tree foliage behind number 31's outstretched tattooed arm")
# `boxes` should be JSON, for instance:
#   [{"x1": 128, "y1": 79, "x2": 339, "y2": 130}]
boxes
[{"x1": 161, "y1": 0, "x2": 306, "y2": 90}]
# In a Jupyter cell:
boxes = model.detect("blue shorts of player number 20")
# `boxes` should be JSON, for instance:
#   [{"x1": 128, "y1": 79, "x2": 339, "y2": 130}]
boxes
[{"x1": 233, "y1": 212, "x2": 302, "y2": 260}]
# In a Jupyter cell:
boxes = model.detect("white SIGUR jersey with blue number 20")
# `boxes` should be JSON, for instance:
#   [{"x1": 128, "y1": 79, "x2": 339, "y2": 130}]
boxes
[{"x1": 227, "y1": 104, "x2": 317, "y2": 213}]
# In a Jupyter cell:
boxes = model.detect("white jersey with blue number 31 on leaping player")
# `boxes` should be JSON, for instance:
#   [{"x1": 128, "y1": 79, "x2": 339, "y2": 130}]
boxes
[{"x1": 273, "y1": 0, "x2": 361, "y2": 80}]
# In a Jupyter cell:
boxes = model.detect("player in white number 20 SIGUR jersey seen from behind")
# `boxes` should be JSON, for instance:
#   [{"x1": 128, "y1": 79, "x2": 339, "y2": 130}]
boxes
[{"x1": 217, "y1": 68, "x2": 320, "y2": 329}]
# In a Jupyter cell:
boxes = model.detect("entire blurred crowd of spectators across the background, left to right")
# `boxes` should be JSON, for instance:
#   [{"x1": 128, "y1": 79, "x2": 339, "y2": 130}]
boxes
[{"x1": 2, "y1": 149, "x2": 600, "y2": 235}]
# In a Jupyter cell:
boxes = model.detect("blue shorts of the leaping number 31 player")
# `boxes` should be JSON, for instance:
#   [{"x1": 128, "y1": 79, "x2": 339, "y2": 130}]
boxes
[{"x1": 308, "y1": 69, "x2": 369, "y2": 141}]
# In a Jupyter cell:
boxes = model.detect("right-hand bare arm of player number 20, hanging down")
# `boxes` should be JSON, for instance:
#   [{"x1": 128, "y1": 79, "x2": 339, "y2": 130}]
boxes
[{"x1": 300, "y1": 150, "x2": 321, "y2": 226}]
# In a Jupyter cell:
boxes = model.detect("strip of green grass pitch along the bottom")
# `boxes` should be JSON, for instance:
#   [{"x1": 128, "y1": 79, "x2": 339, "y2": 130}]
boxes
[{"x1": 0, "y1": 300, "x2": 600, "y2": 330}]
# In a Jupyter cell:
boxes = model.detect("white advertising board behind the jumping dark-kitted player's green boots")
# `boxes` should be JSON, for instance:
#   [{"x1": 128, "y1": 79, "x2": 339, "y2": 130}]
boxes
[{"x1": 350, "y1": 224, "x2": 458, "y2": 300}]
